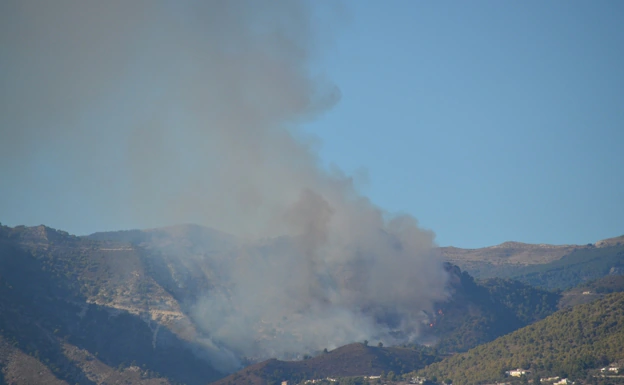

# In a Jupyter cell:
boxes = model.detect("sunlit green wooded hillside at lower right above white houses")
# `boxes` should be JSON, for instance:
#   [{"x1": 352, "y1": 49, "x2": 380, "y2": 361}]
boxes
[{"x1": 419, "y1": 293, "x2": 624, "y2": 385}]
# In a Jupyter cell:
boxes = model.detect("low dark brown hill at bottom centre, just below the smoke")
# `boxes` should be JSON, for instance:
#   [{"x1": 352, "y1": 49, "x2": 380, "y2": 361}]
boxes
[{"x1": 215, "y1": 343, "x2": 436, "y2": 385}]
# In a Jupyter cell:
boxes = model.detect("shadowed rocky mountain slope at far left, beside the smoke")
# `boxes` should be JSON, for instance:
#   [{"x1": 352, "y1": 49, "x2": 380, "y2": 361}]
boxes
[{"x1": 0, "y1": 226, "x2": 219, "y2": 384}]
